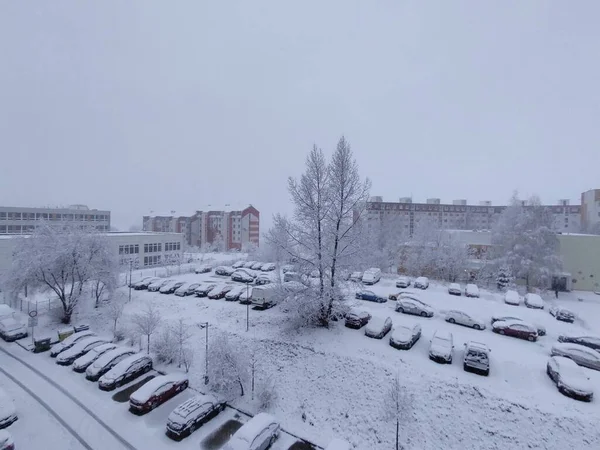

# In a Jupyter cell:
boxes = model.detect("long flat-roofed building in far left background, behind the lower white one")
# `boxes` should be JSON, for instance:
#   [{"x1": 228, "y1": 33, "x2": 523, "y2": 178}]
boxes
[{"x1": 0, "y1": 205, "x2": 110, "y2": 235}]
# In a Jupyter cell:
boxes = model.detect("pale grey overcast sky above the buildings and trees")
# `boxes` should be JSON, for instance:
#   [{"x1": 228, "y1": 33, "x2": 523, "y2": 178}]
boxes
[{"x1": 0, "y1": 0, "x2": 600, "y2": 231}]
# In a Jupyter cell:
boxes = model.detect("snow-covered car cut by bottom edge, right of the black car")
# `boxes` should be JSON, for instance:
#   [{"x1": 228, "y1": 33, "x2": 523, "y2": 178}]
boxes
[{"x1": 223, "y1": 413, "x2": 281, "y2": 450}]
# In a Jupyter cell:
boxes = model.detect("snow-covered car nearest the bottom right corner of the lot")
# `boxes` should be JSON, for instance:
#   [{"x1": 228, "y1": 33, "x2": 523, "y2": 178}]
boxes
[{"x1": 546, "y1": 356, "x2": 594, "y2": 402}]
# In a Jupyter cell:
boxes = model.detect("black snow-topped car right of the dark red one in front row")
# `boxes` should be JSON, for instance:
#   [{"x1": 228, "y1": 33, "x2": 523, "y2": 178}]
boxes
[{"x1": 167, "y1": 394, "x2": 225, "y2": 440}]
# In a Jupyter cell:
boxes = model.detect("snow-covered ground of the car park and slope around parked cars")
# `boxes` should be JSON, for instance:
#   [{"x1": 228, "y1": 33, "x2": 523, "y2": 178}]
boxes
[{"x1": 2, "y1": 266, "x2": 600, "y2": 450}]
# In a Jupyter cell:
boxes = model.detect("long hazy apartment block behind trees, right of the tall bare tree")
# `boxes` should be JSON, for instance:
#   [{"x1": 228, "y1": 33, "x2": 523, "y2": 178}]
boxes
[{"x1": 366, "y1": 196, "x2": 582, "y2": 236}]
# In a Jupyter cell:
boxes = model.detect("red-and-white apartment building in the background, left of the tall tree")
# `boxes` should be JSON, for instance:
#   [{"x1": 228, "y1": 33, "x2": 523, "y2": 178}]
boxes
[{"x1": 143, "y1": 204, "x2": 260, "y2": 250}]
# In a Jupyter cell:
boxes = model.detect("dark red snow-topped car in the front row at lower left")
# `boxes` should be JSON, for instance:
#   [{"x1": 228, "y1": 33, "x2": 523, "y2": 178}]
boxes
[{"x1": 129, "y1": 373, "x2": 190, "y2": 414}]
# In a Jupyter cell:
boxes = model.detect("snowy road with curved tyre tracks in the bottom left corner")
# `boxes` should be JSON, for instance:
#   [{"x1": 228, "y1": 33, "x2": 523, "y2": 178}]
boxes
[{"x1": 0, "y1": 348, "x2": 135, "y2": 450}]
